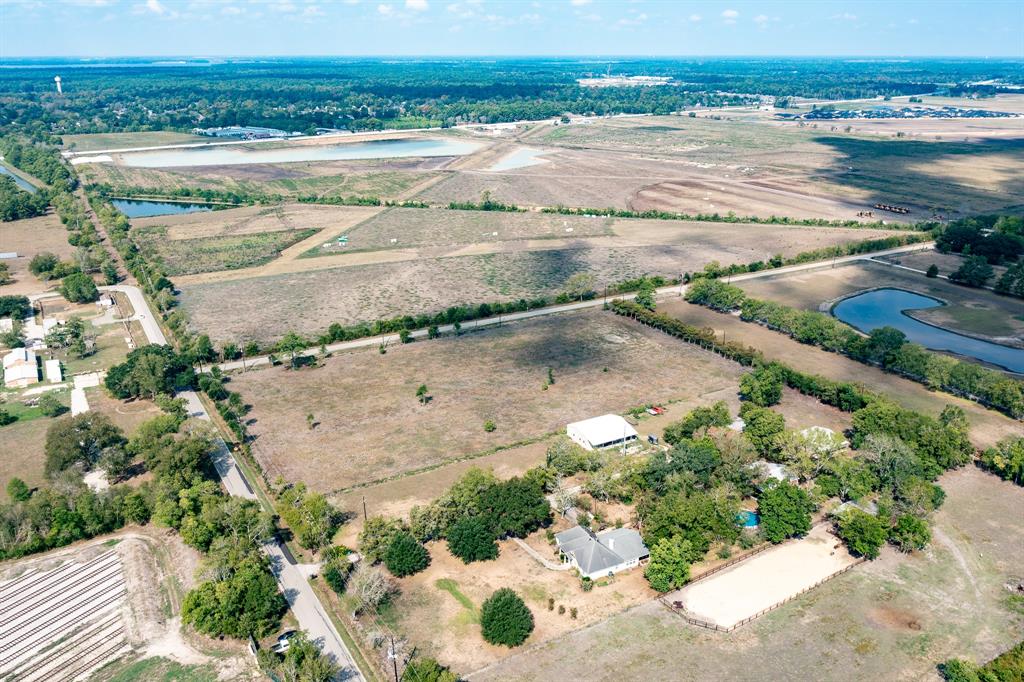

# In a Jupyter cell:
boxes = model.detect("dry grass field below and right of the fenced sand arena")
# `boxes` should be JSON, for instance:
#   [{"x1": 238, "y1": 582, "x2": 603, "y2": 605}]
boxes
[{"x1": 466, "y1": 468, "x2": 1024, "y2": 682}]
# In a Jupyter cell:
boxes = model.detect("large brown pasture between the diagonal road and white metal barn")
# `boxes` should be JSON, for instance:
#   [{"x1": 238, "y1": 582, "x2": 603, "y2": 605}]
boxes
[{"x1": 229, "y1": 310, "x2": 740, "y2": 491}]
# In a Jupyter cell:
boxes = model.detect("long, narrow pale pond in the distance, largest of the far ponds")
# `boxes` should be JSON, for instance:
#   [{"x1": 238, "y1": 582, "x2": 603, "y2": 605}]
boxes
[{"x1": 103, "y1": 137, "x2": 479, "y2": 168}]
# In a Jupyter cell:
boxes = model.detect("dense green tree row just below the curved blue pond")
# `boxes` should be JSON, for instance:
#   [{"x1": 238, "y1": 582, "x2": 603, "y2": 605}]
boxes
[{"x1": 686, "y1": 279, "x2": 1024, "y2": 419}]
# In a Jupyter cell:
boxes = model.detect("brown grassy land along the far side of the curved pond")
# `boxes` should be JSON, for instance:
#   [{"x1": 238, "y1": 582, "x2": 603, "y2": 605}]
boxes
[{"x1": 737, "y1": 259, "x2": 1024, "y2": 346}]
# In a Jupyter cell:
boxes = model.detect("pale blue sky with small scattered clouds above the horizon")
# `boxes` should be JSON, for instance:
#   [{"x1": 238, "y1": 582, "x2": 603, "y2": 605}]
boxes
[{"x1": 0, "y1": 0, "x2": 1024, "y2": 57}]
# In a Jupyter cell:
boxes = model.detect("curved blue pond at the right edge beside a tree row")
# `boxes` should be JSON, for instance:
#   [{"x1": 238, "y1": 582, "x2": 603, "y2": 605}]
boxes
[{"x1": 833, "y1": 289, "x2": 1024, "y2": 373}]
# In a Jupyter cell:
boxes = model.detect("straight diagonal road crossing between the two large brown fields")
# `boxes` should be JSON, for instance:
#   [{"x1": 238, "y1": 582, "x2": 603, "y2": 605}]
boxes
[{"x1": 220, "y1": 242, "x2": 934, "y2": 372}]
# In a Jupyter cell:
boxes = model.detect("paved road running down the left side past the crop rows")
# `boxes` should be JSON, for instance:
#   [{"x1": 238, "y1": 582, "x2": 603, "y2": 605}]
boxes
[{"x1": 100, "y1": 285, "x2": 365, "y2": 680}]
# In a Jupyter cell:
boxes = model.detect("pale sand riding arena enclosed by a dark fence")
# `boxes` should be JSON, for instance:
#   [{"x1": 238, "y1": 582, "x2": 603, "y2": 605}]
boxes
[{"x1": 666, "y1": 525, "x2": 856, "y2": 628}]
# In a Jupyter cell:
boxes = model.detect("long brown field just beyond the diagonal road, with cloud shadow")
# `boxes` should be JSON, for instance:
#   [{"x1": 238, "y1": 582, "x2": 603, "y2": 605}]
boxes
[{"x1": 175, "y1": 216, "x2": 905, "y2": 341}]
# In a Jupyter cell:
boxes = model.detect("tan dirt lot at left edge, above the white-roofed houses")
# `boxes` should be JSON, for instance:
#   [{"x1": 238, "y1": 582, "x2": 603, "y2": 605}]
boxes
[{"x1": 0, "y1": 213, "x2": 75, "y2": 296}]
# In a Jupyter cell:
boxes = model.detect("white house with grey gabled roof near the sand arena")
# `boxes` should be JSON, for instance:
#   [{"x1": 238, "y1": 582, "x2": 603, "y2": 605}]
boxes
[{"x1": 555, "y1": 525, "x2": 650, "y2": 581}]
